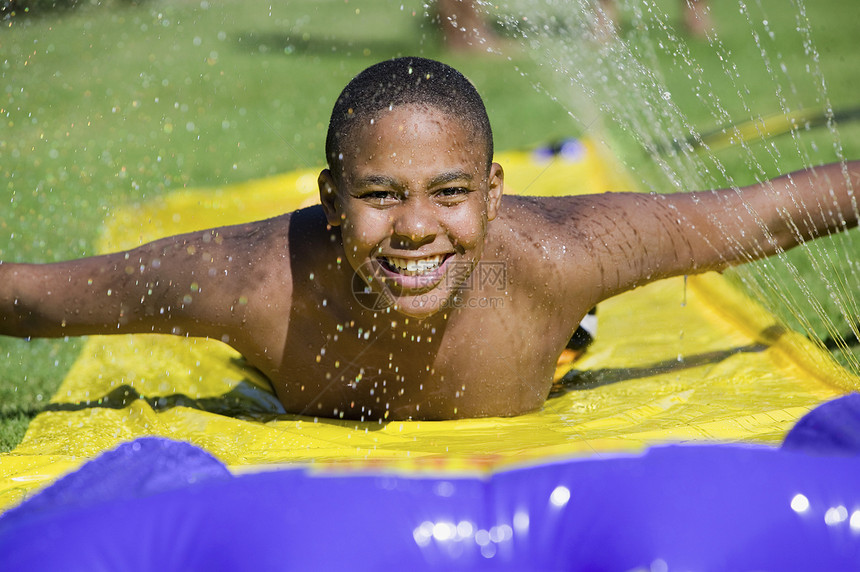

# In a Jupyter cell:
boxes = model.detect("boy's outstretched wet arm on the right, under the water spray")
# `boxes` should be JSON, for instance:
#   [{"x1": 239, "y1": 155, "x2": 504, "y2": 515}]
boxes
[{"x1": 577, "y1": 161, "x2": 860, "y2": 299}]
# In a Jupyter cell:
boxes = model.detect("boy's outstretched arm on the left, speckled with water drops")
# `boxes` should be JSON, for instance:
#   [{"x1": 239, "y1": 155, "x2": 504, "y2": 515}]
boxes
[{"x1": 0, "y1": 217, "x2": 290, "y2": 341}]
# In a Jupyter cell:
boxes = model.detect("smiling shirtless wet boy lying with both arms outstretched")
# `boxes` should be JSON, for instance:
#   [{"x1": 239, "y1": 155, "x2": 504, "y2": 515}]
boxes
[{"x1": 5, "y1": 58, "x2": 860, "y2": 420}]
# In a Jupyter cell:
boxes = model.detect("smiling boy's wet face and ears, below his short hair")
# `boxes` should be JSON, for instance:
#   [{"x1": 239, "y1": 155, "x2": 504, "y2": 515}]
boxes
[{"x1": 320, "y1": 105, "x2": 503, "y2": 318}]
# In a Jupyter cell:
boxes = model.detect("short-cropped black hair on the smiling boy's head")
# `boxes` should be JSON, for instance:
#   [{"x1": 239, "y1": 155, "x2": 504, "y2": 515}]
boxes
[{"x1": 325, "y1": 57, "x2": 493, "y2": 177}]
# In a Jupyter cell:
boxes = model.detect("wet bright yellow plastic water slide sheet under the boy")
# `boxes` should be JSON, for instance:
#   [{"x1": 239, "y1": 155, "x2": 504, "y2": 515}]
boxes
[{"x1": 0, "y1": 141, "x2": 858, "y2": 508}]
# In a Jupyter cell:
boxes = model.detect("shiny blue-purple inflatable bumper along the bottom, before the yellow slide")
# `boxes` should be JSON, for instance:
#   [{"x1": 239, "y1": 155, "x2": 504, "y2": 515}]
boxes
[{"x1": 5, "y1": 400, "x2": 860, "y2": 572}]
